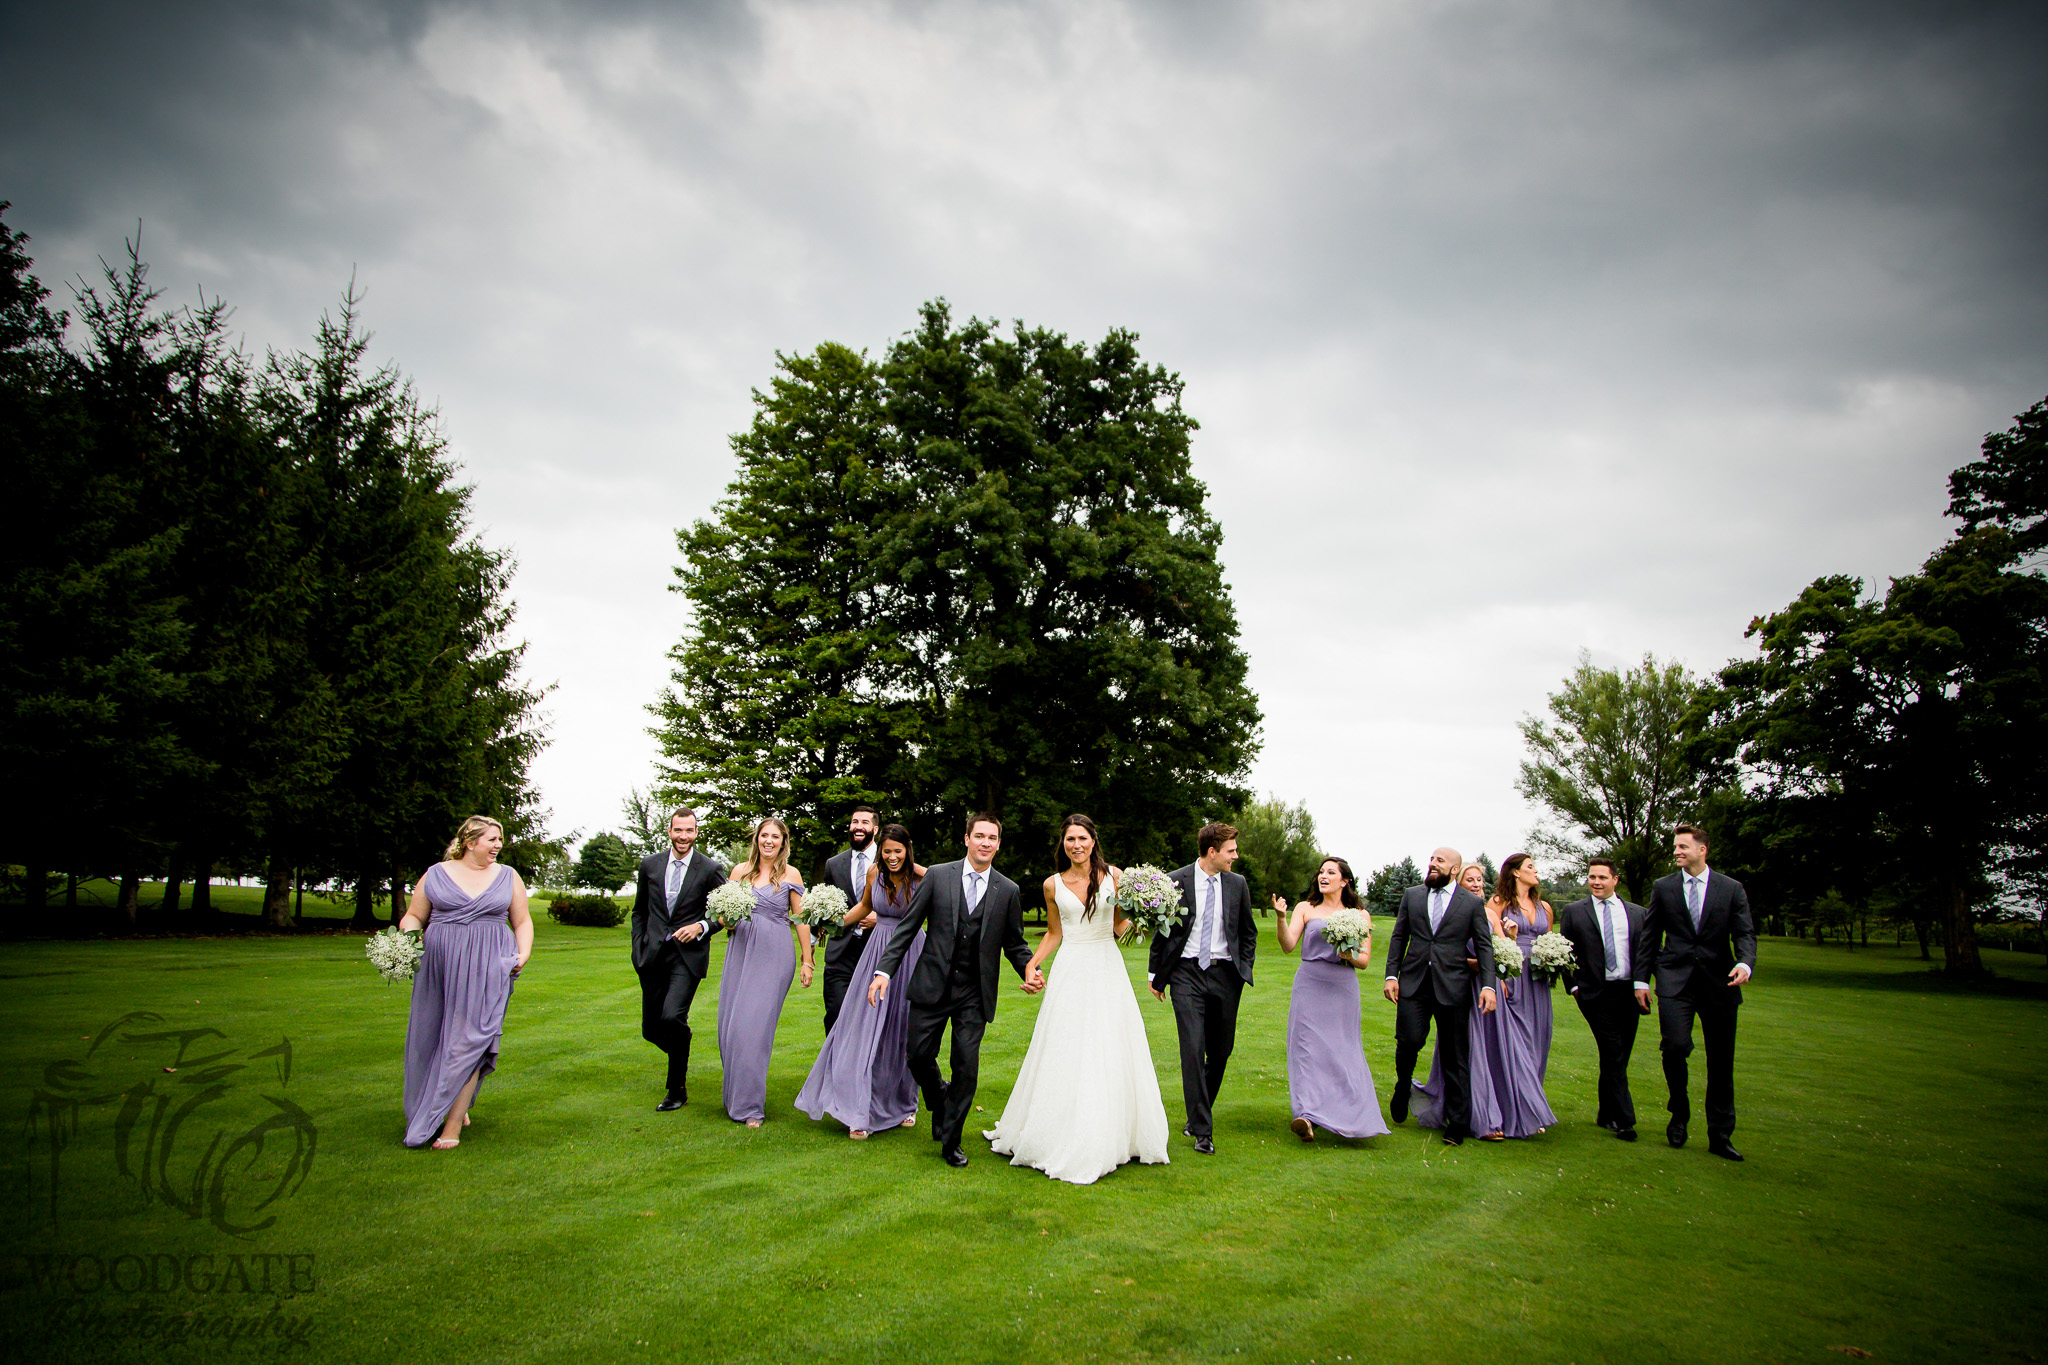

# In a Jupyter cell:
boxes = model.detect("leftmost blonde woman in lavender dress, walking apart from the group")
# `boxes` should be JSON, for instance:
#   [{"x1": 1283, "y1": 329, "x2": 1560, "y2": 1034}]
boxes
[{"x1": 397, "y1": 814, "x2": 532, "y2": 1152}]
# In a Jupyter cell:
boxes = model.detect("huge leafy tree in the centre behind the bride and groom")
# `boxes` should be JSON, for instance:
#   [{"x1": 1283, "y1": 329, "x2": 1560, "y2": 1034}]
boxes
[{"x1": 655, "y1": 303, "x2": 1260, "y2": 868}]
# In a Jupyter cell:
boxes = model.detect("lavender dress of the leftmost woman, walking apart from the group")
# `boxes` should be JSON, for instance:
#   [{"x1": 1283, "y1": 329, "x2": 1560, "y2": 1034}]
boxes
[{"x1": 406, "y1": 864, "x2": 518, "y2": 1146}]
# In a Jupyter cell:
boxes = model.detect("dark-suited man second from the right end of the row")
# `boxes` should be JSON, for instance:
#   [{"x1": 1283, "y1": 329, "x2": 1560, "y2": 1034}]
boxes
[{"x1": 1556, "y1": 857, "x2": 1651, "y2": 1142}]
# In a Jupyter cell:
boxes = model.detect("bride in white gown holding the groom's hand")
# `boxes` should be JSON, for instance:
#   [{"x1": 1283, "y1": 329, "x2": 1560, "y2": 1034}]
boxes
[{"x1": 983, "y1": 814, "x2": 1167, "y2": 1185}]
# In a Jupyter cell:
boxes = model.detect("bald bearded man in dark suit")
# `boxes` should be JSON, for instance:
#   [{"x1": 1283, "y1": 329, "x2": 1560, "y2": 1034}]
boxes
[{"x1": 1384, "y1": 847, "x2": 1497, "y2": 1146}]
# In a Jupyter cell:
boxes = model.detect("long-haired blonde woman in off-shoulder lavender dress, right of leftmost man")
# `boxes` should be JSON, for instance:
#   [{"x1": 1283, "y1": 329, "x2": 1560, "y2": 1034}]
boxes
[{"x1": 719, "y1": 814, "x2": 811, "y2": 1128}]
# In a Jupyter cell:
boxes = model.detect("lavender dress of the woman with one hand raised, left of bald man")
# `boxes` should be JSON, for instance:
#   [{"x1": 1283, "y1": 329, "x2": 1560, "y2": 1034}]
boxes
[{"x1": 1286, "y1": 919, "x2": 1386, "y2": 1138}]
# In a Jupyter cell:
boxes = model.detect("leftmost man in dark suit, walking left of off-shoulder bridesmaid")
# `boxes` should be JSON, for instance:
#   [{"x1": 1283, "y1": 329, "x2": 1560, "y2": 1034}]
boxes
[{"x1": 633, "y1": 806, "x2": 725, "y2": 1113}]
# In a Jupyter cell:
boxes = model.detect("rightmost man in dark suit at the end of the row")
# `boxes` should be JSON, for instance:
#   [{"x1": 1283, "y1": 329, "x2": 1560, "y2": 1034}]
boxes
[{"x1": 1636, "y1": 825, "x2": 1757, "y2": 1160}]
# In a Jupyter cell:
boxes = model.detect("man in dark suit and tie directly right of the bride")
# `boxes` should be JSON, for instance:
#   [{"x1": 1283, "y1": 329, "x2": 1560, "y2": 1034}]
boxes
[{"x1": 1147, "y1": 821, "x2": 1260, "y2": 1156}]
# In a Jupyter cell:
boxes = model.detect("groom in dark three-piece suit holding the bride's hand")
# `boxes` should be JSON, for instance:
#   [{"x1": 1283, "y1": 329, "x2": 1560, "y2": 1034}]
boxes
[{"x1": 868, "y1": 814, "x2": 1044, "y2": 1166}]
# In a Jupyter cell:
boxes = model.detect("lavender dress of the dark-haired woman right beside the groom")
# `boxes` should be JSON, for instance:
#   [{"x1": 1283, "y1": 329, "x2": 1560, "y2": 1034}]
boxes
[{"x1": 797, "y1": 876, "x2": 924, "y2": 1132}]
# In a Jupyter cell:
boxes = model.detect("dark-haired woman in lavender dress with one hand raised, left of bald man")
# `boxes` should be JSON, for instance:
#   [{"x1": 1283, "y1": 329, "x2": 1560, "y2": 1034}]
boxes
[{"x1": 1274, "y1": 855, "x2": 1389, "y2": 1142}]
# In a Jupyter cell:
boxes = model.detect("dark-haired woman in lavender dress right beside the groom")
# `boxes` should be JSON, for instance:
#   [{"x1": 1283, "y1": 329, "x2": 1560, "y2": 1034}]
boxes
[{"x1": 797, "y1": 825, "x2": 924, "y2": 1140}]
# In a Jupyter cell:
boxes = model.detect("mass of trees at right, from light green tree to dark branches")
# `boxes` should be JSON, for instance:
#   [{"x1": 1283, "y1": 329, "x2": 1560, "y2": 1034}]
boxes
[{"x1": 1522, "y1": 401, "x2": 2048, "y2": 976}]
